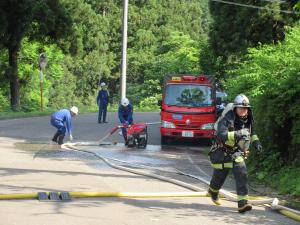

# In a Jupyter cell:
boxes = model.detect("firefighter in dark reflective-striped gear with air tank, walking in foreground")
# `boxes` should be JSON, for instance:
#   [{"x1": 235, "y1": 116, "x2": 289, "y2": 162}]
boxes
[{"x1": 208, "y1": 94, "x2": 262, "y2": 213}]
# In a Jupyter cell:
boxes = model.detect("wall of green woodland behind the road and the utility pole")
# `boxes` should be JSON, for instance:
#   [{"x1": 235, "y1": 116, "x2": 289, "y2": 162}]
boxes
[{"x1": 0, "y1": 0, "x2": 209, "y2": 110}]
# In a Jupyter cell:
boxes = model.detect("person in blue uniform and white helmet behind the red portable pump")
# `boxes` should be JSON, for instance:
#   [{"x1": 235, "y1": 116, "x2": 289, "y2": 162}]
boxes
[{"x1": 118, "y1": 98, "x2": 133, "y2": 145}]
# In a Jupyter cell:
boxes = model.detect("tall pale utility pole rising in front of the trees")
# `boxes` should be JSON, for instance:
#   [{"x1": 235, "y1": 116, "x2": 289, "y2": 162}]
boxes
[{"x1": 121, "y1": 0, "x2": 128, "y2": 99}]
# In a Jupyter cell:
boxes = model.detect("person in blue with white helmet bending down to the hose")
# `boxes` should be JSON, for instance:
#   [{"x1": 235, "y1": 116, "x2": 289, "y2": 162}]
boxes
[{"x1": 50, "y1": 106, "x2": 78, "y2": 145}]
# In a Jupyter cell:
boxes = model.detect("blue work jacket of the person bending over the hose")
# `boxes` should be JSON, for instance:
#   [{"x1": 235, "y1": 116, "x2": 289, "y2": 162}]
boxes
[{"x1": 50, "y1": 109, "x2": 72, "y2": 135}]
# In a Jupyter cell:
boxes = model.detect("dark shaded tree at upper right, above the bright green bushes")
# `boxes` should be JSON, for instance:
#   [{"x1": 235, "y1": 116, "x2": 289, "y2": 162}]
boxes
[{"x1": 209, "y1": 0, "x2": 297, "y2": 79}]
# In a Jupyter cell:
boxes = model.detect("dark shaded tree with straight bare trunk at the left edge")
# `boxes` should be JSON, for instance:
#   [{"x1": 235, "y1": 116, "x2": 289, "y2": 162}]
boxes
[{"x1": 0, "y1": 0, "x2": 69, "y2": 110}]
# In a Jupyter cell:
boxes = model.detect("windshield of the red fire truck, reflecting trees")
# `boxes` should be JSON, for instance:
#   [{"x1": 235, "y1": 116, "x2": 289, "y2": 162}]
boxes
[{"x1": 164, "y1": 84, "x2": 213, "y2": 107}]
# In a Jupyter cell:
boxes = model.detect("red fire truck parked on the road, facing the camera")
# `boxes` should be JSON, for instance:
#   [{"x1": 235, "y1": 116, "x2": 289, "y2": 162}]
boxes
[{"x1": 159, "y1": 74, "x2": 217, "y2": 145}]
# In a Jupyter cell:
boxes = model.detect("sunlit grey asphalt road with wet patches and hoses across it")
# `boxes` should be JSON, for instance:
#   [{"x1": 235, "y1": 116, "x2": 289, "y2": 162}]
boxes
[{"x1": 0, "y1": 113, "x2": 299, "y2": 225}]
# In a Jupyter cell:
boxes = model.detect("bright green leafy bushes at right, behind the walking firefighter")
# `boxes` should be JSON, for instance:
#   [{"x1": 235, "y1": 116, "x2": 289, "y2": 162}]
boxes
[{"x1": 226, "y1": 26, "x2": 300, "y2": 194}]
